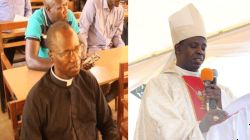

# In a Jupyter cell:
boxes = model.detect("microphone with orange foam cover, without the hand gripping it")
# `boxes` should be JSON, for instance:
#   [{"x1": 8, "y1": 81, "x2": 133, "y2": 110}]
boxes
[{"x1": 201, "y1": 68, "x2": 217, "y2": 111}]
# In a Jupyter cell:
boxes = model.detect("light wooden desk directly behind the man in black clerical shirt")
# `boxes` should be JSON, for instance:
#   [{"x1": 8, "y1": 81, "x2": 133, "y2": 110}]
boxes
[{"x1": 3, "y1": 47, "x2": 128, "y2": 100}]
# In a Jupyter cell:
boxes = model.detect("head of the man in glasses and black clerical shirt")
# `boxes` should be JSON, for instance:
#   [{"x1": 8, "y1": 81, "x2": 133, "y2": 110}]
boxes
[{"x1": 52, "y1": 28, "x2": 82, "y2": 79}]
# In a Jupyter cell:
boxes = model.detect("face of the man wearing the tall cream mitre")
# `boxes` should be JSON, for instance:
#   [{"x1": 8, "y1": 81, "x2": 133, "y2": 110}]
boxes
[{"x1": 175, "y1": 36, "x2": 207, "y2": 72}]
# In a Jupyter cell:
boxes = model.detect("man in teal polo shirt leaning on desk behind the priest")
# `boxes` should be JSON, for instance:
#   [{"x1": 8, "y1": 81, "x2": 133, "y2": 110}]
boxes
[{"x1": 25, "y1": 0, "x2": 79, "y2": 70}]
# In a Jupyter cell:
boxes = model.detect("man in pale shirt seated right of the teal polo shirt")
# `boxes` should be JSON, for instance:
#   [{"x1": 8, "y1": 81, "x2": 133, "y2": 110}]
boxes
[{"x1": 80, "y1": 0, "x2": 125, "y2": 54}]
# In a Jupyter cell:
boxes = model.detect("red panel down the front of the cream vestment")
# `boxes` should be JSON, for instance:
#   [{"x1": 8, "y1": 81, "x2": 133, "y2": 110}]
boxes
[{"x1": 183, "y1": 76, "x2": 207, "y2": 121}]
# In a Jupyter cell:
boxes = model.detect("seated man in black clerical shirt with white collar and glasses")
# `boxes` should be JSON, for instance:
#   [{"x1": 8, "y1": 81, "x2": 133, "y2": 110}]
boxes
[{"x1": 21, "y1": 21, "x2": 119, "y2": 140}]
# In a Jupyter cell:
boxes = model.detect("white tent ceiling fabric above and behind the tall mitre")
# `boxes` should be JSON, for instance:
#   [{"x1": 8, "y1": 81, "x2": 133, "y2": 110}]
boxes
[{"x1": 129, "y1": 0, "x2": 250, "y2": 62}]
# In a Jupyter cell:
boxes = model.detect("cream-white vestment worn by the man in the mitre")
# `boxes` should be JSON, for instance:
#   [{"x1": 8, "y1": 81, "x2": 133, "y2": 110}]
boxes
[{"x1": 134, "y1": 65, "x2": 232, "y2": 140}]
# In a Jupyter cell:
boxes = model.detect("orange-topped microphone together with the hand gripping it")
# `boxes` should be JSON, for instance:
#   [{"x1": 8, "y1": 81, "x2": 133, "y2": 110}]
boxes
[{"x1": 201, "y1": 68, "x2": 221, "y2": 110}]
